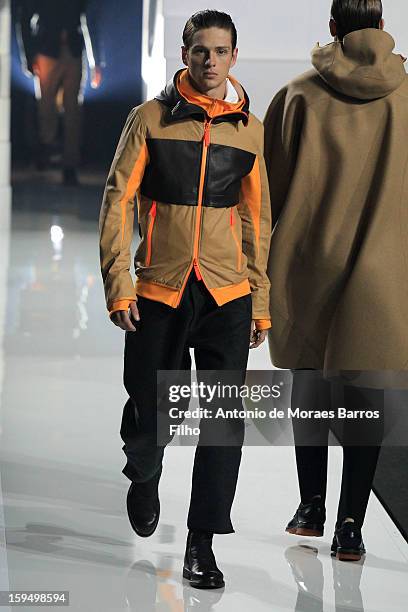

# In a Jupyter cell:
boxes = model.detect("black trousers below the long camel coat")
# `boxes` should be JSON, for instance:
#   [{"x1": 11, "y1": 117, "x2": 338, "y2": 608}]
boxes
[{"x1": 292, "y1": 370, "x2": 384, "y2": 527}]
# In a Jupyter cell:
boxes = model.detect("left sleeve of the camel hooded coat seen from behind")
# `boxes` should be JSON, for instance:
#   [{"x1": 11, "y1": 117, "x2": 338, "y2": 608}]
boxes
[{"x1": 264, "y1": 87, "x2": 304, "y2": 226}]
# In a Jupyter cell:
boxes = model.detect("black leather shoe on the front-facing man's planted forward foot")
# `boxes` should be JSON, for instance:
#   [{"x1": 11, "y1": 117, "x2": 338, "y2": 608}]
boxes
[{"x1": 183, "y1": 531, "x2": 225, "y2": 589}]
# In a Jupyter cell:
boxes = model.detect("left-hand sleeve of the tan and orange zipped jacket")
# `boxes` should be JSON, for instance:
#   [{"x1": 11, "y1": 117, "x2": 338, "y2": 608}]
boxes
[{"x1": 99, "y1": 108, "x2": 148, "y2": 314}]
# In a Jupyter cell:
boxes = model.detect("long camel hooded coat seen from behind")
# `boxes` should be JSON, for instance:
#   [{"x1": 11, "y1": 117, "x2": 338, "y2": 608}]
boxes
[{"x1": 265, "y1": 29, "x2": 408, "y2": 378}]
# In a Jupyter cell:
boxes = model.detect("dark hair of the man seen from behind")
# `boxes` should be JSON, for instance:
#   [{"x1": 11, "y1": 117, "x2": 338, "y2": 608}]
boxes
[{"x1": 331, "y1": 0, "x2": 383, "y2": 40}]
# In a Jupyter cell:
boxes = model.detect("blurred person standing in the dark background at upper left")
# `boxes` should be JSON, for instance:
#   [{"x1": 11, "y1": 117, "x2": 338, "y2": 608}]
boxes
[{"x1": 17, "y1": 0, "x2": 102, "y2": 185}]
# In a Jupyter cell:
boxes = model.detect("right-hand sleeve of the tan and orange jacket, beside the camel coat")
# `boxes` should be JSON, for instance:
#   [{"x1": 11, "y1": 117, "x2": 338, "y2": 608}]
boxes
[{"x1": 238, "y1": 120, "x2": 271, "y2": 329}]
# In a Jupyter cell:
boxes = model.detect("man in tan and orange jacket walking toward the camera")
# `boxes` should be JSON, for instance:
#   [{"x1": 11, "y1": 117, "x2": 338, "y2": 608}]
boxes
[{"x1": 100, "y1": 11, "x2": 271, "y2": 588}]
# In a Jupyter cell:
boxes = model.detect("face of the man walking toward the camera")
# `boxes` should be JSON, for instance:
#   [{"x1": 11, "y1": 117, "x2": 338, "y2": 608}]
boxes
[{"x1": 182, "y1": 28, "x2": 238, "y2": 93}]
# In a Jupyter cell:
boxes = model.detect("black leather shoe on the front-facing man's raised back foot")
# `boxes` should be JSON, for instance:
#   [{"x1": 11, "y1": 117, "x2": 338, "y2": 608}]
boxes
[{"x1": 126, "y1": 468, "x2": 162, "y2": 538}]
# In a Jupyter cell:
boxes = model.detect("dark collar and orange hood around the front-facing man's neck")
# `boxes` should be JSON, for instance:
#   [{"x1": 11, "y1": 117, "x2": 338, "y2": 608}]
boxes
[{"x1": 156, "y1": 69, "x2": 250, "y2": 125}]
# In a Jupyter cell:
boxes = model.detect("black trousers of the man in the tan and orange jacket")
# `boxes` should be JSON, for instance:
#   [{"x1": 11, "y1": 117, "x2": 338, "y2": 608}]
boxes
[{"x1": 120, "y1": 273, "x2": 252, "y2": 533}]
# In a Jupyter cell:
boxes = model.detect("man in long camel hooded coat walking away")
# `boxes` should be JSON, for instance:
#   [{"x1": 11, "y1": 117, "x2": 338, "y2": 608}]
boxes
[{"x1": 265, "y1": 0, "x2": 408, "y2": 560}]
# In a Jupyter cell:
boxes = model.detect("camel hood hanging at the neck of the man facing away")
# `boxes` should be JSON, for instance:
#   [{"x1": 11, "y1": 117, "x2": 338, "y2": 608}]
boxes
[{"x1": 312, "y1": 28, "x2": 406, "y2": 100}]
